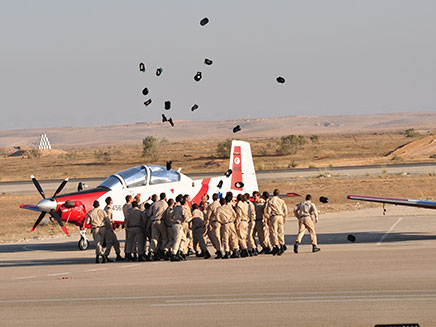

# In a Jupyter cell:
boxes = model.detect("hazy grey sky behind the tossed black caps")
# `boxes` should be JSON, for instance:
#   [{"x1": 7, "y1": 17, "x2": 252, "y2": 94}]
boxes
[{"x1": 0, "y1": 0, "x2": 436, "y2": 129}]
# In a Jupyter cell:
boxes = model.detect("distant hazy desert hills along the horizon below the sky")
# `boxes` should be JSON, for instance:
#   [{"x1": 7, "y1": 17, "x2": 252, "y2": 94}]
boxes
[{"x1": 0, "y1": 112, "x2": 436, "y2": 148}]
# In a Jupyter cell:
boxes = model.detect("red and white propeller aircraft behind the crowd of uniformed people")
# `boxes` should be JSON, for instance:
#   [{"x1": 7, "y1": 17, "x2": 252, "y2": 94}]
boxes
[{"x1": 20, "y1": 140, "x2": 258, "y2": 250}]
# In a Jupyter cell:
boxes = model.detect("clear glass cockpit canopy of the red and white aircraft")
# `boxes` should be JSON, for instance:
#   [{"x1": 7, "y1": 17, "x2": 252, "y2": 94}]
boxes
[{"x1": 100, "y1": 165, "x2": 180, "y2": 191}]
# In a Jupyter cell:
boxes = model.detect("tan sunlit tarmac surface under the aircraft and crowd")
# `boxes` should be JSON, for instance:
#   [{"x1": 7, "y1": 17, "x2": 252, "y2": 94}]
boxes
[{"x1": 0, "y1": 207, "x2": 436, "y2": 327}]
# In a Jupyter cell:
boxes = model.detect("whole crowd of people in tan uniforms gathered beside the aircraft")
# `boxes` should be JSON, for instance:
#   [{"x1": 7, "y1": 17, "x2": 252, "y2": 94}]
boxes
[{"x1": 87, "y1": 189, "x2": 320, "y2": 263}]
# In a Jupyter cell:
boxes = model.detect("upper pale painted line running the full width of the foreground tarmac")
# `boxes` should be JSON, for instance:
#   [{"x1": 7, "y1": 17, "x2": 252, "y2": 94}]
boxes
[{"x1": 0, "y1": 290, "x2": 436, "y2": 305}]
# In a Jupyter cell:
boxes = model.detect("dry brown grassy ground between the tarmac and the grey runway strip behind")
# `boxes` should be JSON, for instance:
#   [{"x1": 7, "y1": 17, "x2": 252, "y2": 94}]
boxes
[{"x1": 0, "y1": 176, "x2": 436, "y2": 242}]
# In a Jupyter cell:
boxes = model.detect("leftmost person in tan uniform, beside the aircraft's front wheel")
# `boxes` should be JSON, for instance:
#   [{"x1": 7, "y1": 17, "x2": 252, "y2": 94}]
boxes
[{"x1": 85, "y1": 200, "x2": 108, "y2": 263}]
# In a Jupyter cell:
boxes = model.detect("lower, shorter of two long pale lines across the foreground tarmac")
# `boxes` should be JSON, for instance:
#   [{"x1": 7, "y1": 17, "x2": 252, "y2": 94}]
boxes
[{"x1": 150, "y1": 296, "x2": 436, "y2": 307}]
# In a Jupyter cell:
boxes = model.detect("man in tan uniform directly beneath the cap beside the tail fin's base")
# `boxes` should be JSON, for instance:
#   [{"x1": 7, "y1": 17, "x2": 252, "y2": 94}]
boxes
[{"x1": 216, "y1": 194, "x2": 240, "y2": 259}]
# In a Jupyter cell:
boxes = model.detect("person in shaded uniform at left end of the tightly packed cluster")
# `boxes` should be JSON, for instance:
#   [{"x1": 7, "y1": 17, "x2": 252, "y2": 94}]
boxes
[{"x1": 125, "y1": 201, "x2": 145, "y2": 261}]
